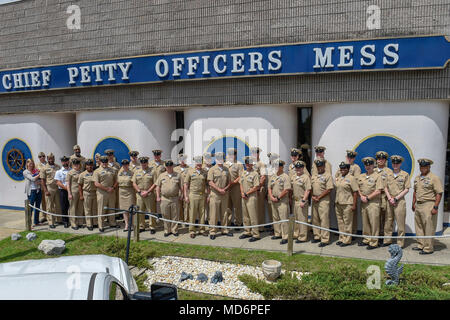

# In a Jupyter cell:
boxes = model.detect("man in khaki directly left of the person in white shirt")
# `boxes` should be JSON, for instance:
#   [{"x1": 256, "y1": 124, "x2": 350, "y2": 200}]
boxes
[{"x1": 39, "y1": 153, "x2": 62, "y2": 229}]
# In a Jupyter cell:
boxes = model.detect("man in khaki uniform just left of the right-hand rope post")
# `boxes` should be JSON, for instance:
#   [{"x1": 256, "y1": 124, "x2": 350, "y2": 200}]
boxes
[{"x1": 267, "y1": 159, "x2": 291, "y2": 244}]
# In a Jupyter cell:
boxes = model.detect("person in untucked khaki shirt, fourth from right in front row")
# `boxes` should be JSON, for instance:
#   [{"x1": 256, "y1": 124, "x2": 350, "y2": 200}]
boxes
[{"x1": 335, "y1": 162, "x2": 358, "y2": 247}]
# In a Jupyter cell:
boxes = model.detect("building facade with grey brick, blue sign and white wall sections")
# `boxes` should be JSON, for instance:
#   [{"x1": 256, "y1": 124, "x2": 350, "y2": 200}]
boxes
[{"x1": 0, "y1": 0, "x2": 450, "y2": 233}]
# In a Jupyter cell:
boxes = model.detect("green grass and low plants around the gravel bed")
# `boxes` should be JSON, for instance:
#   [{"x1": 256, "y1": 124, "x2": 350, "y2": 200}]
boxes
[{"x1": 0, "y1": 232, "x2": 450, "y2": 300}]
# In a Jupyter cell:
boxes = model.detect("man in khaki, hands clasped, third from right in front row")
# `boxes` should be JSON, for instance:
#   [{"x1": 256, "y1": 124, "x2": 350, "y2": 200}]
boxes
[{"x1": 358, "y1": 157, "x2": 384, "y2": 250}]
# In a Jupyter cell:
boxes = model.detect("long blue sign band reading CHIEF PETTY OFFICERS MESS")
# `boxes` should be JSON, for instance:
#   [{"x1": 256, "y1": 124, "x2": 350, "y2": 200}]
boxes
[{"x1": 0, "y1": 36, "x2": 450, "y2": 93}]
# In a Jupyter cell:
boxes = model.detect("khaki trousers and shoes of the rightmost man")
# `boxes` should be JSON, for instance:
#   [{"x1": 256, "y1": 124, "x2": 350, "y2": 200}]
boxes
[{"x1": 414, "y1": 201, "x2": 438, "y2": 252}]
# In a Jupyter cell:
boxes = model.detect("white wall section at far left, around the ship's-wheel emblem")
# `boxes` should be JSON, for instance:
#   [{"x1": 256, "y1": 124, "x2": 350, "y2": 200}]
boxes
[{"x1": 0, "y1": 113, "x2": 76, "y2": 207}]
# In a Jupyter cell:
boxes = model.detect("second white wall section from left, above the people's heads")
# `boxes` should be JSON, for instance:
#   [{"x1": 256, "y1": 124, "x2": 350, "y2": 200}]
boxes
[{"x1": 76, "y1": 109, "x2": 175, "y2": 159}]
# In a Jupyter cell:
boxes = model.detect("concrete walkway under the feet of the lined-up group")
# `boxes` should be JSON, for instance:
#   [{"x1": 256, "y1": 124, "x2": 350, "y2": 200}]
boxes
[{"x1": 0, "y1": 210, "x2": 450, "y2": 265}]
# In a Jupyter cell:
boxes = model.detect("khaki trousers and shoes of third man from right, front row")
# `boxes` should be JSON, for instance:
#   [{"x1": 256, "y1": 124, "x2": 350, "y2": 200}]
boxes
[{"x1": 361, "y1": 200, "x2": 380, "y2": 247}]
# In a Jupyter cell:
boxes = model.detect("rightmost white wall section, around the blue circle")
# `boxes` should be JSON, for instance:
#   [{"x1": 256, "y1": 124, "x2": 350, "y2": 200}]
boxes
[{"x1": 312, "y1": 101, "x2": 449, "y2": 233}]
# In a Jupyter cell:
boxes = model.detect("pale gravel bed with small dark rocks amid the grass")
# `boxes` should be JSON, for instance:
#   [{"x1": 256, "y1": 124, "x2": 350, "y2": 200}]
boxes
[{"x1": 145, "y1": 256, "x2": 310, "y2": 300}]
